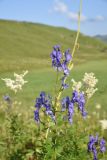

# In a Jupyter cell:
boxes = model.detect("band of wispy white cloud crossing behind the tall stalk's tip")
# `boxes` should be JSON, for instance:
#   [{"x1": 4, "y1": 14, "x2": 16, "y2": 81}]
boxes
[{"x1": 49, "y1": 0, "x2": 107, "y2": 23}]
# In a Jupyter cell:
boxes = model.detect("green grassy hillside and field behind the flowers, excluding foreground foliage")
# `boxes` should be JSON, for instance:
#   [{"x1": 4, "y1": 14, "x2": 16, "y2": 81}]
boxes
[{"x1": 0, "y1": 20, "x2": 107, "y2": 117}]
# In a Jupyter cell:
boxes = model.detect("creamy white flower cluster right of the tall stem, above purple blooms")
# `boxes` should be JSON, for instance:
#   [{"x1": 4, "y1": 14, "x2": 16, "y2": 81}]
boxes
[{"x1": 71, "y1": 73, "x2": 98, "y2": 99}]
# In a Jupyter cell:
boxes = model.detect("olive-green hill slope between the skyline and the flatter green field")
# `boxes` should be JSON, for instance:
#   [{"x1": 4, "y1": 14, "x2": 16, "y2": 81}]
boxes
[{"x1": 0, "y1": 20, "x2": 107, "y2": 72}]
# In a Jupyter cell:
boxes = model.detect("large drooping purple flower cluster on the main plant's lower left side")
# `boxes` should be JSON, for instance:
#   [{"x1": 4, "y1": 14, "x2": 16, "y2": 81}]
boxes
[{"x1": 34, "y1": 92, "x2": 55, "y2": 122}]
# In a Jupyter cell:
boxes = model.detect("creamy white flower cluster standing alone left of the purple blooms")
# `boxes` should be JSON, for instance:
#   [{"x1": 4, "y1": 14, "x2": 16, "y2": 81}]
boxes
[{"x1": 2, "y1": 71, "x2": 28, "y2": 93}]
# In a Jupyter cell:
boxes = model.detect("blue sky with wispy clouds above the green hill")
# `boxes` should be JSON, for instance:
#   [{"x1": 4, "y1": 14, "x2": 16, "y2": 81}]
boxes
[{"x1": 0, "y1": 0, "x2": 107, "y2": 36}]
